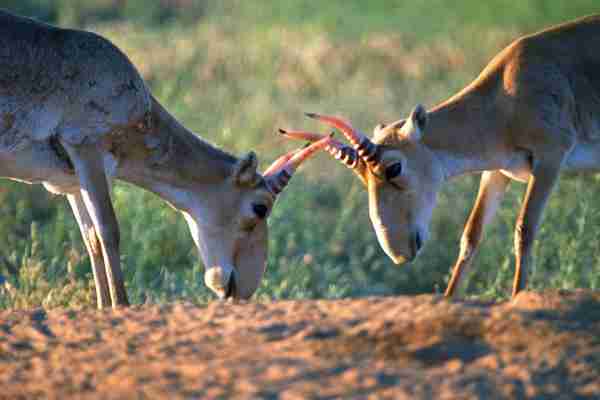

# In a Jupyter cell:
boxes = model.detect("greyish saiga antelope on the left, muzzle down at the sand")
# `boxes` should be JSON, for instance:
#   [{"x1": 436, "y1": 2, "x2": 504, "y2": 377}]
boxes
[{"x1": 0, "y1": 11, "x2": 327, "y2": 308}]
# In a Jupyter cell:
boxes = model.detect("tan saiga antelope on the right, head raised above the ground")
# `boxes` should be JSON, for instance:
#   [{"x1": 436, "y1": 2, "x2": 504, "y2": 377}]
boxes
[{"x1": 282, "y1": 16, "x2": 600, "y2": 297}]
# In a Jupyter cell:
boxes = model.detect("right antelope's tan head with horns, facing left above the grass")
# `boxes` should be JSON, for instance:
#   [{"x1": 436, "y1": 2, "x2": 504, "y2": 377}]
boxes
[{"x1": 280, "y1": 105, "x2": 443, "y2": 264}]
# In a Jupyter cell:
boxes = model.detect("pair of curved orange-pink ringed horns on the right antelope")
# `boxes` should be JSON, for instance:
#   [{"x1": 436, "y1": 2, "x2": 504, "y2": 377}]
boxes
[{"x1": 279, "y1": 113, "x2": 379, "y2": 169}]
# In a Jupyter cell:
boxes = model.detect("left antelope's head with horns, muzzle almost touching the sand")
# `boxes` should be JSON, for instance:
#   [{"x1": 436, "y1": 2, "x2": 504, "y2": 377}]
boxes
[{"x1": 183, "y1": 137, "x2": 330, "y2": 299}]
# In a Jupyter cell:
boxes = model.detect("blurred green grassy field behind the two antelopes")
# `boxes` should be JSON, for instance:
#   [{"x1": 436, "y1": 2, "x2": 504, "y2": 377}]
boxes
[{"x1": 0, "y1": 0, "x2": 600, "y2": 308}]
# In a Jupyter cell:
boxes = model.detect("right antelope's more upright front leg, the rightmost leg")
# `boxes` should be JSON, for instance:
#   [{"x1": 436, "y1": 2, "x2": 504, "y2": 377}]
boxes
[{"x1": 512, "y1": 154, "x2": 564, "y2": 298}]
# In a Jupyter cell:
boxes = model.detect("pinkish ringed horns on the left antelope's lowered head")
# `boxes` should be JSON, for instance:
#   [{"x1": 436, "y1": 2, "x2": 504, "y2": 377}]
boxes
[{"x1": 263, "y1": 136, "x2": 332, "y2": 196}]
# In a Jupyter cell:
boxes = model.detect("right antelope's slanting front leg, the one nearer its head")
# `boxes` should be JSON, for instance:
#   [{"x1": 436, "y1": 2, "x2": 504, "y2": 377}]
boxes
[{"x1": 444, "y1": 171, "x2": 510, "y2": 297}]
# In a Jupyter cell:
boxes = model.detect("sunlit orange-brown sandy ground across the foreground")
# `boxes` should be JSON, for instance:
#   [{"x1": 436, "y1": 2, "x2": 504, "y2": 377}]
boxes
[{"x1": 0, "y1": 291, "x2": 600, "y2": 399}]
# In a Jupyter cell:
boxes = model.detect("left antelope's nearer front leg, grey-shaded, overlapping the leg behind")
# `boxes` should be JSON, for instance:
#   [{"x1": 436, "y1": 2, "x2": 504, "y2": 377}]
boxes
[{"x1": 63, "y1": 143, "x2": 129, "y2": 308}]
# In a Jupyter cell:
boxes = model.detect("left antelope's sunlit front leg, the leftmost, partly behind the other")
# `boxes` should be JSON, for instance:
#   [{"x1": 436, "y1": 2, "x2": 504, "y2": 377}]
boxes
[{"x1": 67, "y1": 193, "x2": 111, "y2": 309}]
